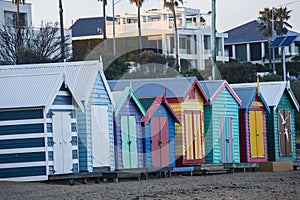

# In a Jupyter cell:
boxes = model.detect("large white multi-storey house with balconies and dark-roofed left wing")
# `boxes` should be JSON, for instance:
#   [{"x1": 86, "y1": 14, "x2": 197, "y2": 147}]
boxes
[{"x1": 71, "y1": 7, "x2": 229, "y2": 71}]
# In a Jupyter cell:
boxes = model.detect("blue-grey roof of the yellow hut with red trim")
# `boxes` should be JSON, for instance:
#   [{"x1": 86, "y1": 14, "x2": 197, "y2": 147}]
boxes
[{"x1": 108, "y1": 77, "x2": 207, "y2": 100}]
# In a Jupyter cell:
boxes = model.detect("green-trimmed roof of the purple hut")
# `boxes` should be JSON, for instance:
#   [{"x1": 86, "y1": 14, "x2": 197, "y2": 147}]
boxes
[{"x1": 112, "y1": 87, "x2": 146, "y2": 115}]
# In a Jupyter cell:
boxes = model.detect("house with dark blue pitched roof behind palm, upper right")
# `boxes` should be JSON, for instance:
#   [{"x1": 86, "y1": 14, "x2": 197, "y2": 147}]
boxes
[{"x1": 224, "y1": 20, "x2": 300, "y2": 63}]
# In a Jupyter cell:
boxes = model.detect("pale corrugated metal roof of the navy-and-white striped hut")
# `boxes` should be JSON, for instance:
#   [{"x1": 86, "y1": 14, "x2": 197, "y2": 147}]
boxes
[{"x1": 0, "y1": 73, "x2": 63, "y2": 109}]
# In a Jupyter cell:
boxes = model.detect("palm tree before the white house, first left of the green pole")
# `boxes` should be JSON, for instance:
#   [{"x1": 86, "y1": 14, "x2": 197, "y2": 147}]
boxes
[{"x1": 164, "y1": 0, "x2": 183, "y2": 72}]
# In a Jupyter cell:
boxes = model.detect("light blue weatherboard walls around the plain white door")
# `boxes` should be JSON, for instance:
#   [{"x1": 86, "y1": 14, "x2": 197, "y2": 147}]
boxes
[{"x1": 78, "y1": 74, "x2": 115, "y2": 172}]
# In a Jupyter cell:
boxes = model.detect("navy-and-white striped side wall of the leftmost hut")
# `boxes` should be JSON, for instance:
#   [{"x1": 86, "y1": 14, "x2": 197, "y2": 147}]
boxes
[{"x1": 0, "y1": 109, "x2": 47, "y2": 181}]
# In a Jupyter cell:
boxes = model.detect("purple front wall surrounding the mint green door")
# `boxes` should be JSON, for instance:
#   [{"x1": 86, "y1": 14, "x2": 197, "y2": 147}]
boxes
[{"x1": 115, "y1": 98, "x2": 144, "y2": 169}]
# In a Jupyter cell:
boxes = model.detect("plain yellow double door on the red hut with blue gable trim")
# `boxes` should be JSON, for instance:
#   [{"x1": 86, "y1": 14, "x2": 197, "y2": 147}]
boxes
[{"x1": 249, "y1": 110, "x2": 265, "y2": 158}]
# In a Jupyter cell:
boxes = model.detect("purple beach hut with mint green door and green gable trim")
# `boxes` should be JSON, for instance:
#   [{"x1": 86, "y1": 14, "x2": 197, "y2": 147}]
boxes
[{"x1": 112, "y1": 87, "x2": 146, "y2": 169}]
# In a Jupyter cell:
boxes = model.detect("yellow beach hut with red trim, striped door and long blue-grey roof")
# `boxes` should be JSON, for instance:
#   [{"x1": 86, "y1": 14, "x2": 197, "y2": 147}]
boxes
[{"x1": 109, "y1": 77, "x2": 207, "y2": 166}]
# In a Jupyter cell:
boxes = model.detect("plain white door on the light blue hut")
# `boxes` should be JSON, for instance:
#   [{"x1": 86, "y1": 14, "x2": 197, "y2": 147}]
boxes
[{"x1": 91, "y1": 105, "x2": 110, "y2": 167}]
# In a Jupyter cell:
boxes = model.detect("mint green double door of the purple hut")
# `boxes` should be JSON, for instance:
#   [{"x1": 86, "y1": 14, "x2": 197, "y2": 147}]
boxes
[{"x1": 121, "y1": 116, "x2": 138, "y2": 168}]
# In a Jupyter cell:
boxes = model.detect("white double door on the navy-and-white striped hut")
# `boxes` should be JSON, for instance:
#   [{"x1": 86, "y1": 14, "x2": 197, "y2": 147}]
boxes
[{"x1": 52, "y1": 112, "x2": 73, "y2": 174}]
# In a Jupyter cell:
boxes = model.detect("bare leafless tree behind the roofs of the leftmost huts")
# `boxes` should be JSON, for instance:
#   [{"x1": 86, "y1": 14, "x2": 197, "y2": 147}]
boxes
[{"x1": 0, "y1": 22, "x2": 71, "y2": 65}]
